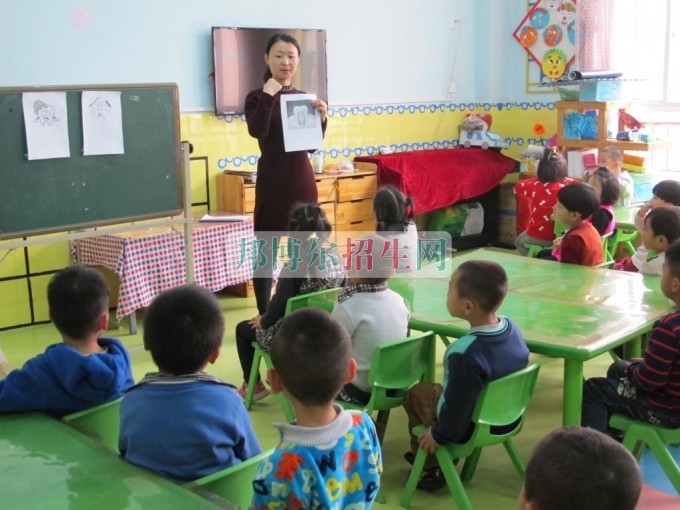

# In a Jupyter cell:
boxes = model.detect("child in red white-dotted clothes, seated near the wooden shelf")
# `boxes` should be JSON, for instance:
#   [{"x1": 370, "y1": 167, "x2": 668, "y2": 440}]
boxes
[{"x1": 515, "y1": 148, "x2": 574, "y2": 255}]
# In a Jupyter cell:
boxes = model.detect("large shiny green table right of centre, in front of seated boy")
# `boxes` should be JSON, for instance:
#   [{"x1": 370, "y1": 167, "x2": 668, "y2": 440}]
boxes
[{"x1": 390, "y1": 249, "x2": 671, "y2": 425}]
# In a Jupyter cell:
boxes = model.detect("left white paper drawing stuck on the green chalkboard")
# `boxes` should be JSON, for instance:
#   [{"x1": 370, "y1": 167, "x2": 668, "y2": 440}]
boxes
[{"x1": 21, "y1": 92, "x2": 71, "y2": 160}]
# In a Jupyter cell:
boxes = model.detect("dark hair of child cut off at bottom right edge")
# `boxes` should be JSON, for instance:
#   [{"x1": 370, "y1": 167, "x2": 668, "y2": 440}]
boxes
[{"x1": 524, "y1": 427, "x2": 642, "y2": 510}]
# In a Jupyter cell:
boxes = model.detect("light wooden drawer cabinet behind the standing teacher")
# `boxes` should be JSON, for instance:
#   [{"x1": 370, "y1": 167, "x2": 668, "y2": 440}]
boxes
[{"x1": 217, "y1": 162, "x2": 378, "y2": 296}]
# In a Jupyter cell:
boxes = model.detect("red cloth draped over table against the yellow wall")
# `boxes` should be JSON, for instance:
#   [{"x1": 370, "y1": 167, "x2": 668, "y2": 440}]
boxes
[{"x1": 354, "y1": 147, "x2": 517, "y2": 214}]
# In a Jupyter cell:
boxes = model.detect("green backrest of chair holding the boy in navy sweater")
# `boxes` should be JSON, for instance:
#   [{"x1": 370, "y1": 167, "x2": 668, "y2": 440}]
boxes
[{"x1": 472, "y1": 363, "x2": 540, "y2": 429}]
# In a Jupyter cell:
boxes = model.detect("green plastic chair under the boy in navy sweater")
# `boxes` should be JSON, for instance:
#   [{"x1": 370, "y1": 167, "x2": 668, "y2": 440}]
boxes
[{"x1": 401, "y1": 363, "x2": 540, "y2": 510}]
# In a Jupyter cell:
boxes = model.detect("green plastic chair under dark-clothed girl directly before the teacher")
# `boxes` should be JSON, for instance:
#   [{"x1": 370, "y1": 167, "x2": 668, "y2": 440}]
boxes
[{"x1": 243, "y1": 287, "x2": 342, "y2": 422}]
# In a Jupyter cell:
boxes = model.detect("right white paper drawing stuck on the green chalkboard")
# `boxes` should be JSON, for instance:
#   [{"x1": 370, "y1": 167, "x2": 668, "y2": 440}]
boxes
[{"x1": 81, "y1": 90, "x2": 125, "y2": 156}]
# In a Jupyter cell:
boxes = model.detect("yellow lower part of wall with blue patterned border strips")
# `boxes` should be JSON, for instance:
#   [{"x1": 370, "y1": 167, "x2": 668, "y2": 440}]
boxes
[{"x1": 0, "y1": 103, "x2": 557, "y2": 329}]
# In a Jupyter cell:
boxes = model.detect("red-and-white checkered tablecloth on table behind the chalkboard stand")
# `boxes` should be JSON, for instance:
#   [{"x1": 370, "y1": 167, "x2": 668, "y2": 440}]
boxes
[{"x1": 72, "y1": 219, "x2": 254, "y2": 320}]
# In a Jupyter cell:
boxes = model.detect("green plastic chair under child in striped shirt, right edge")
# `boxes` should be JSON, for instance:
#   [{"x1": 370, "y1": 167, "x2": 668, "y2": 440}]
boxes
[{"x1": 609, "y1": 414, "x2": 680, "y2": 494}]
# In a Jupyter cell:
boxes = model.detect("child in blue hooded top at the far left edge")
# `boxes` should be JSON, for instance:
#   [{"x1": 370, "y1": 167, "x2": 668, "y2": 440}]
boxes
[{"x1": 0, "y1": 266, "x2": 134, "y2": 418}]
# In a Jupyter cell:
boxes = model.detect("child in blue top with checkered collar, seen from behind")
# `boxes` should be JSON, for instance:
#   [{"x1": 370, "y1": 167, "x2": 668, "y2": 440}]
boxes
[{"x1": 118, "y1": 285, "x2": 261, "y2": 481}]
